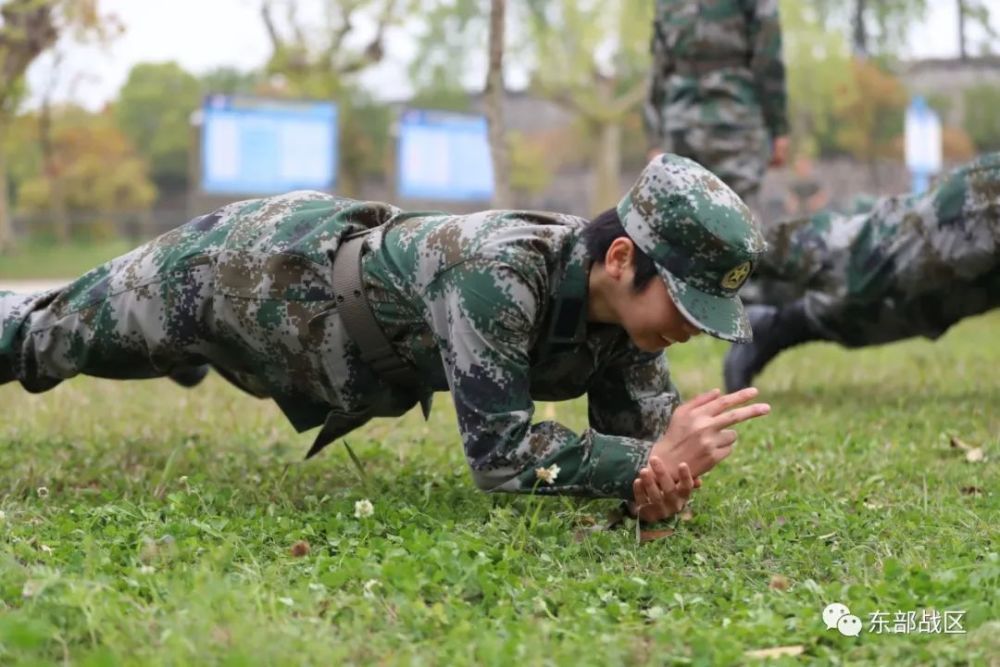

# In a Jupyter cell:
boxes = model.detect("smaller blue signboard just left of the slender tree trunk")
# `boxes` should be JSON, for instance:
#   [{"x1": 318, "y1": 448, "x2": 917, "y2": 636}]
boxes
[{"x1": 396, "y1": 109, "x2": 493, "y2": 201}]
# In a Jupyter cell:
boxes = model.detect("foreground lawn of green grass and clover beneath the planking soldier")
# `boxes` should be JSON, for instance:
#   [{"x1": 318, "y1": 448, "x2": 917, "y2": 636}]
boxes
[{"x1": 0, "y1": 313, "x2": 1000, "y2": 665}]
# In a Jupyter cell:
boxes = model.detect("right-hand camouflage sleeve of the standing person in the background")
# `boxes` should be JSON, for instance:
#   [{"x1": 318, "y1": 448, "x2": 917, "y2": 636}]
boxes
[{"x1": 749, "y1": 0, "x2": 788, "y2": 139}]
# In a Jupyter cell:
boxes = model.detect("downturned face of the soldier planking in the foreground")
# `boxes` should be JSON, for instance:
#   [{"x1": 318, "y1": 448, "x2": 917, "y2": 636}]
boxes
[{"x1": 618, "y1": 276, "x2": 701, "y2": 352}]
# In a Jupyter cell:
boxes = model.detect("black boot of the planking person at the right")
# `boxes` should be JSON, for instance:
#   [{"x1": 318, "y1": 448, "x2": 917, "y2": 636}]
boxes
[{"x1": 722, "y1": 299, "x2": 827, "y2": 391}]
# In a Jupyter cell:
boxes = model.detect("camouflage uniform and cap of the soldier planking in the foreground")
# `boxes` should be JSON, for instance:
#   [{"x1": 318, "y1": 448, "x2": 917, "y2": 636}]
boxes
[{"x1": 0, "y1": 158, "x2": 762, "y2": 498}]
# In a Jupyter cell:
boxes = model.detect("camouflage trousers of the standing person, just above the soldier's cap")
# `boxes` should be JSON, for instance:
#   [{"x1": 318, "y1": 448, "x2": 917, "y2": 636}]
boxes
[{"x1": 665, "y1": 125, "x2": 770, "y2": 217}]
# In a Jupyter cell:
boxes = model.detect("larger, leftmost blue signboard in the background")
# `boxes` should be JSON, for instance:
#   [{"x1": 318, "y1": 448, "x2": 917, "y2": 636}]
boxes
[{"x1": 201, "y1": 95, "x2": 337, "y2": 195}]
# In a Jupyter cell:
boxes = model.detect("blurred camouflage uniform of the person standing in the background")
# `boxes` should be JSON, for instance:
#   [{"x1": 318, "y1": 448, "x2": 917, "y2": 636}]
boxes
[{"x1": 646, "y1": 0, "x2": 788, "y2": 205}]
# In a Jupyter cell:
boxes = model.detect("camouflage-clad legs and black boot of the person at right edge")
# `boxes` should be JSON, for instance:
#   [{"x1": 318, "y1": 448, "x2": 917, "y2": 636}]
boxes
[{"x1": 725, "y1": 153, "x2": 1000, "y2": 389}]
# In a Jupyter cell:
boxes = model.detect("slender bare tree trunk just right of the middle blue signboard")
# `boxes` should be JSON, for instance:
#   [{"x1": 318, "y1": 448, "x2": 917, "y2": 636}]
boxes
[{"x1": 485, "y1": 0, "x2": 511, "y2": 208}]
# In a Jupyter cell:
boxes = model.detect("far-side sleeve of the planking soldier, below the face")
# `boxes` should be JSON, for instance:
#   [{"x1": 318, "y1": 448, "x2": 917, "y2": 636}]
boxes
[{"x1": 587, "y1": 343, "x2": 680, "y2": 440}]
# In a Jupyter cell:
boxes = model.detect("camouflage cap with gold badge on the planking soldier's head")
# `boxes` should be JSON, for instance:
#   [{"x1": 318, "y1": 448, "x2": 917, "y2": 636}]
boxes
[{"x1": 618, "y1": 153, "x2": 766, "y2": 343}]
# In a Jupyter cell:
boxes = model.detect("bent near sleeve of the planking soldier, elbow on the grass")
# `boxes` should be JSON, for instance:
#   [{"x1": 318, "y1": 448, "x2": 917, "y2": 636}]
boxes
[{"x1": 427, "y1": 260, "x2": 652, "y2": 498}]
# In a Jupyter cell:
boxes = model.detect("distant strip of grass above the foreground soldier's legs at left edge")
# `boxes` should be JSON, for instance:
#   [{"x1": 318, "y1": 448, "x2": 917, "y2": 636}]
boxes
[{"x1": 0, "y1": 240, "x2": 132, "y2": 280}]
